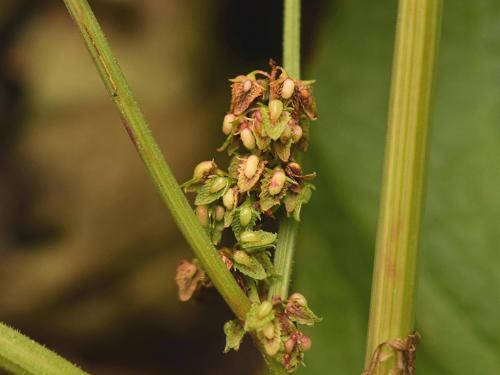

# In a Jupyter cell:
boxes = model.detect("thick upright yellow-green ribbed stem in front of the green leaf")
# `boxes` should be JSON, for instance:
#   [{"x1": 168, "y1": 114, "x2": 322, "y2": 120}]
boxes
[{"x1": 366, "y1": 0, "x2": 441, "y2": 374}]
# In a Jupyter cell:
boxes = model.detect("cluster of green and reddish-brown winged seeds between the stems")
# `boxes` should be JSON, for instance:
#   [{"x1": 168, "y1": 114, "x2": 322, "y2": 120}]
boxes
[{"x1": 176, "y1": 61, "x2": 319, "y2": 372}]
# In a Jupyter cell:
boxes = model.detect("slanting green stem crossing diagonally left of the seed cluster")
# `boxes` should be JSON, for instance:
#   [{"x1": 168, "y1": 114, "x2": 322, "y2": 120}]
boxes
[{"x1": 64, "y1": 0, "x2": 250, "y2": 320}]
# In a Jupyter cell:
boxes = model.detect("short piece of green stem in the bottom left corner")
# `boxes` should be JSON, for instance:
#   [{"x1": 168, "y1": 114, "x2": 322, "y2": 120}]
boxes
[{"x1": 0, "y1": 323, "x2": 86, "y2": 375}]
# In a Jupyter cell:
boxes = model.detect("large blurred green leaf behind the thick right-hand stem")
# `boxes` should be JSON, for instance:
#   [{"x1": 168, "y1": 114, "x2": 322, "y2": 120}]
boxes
[{"x1": 296, "y1": 0, "x2": 500, "y2": 375}]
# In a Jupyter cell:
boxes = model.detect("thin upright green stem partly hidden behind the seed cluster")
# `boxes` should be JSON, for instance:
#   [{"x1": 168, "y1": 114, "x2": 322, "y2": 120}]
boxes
[{"x1": 269, "y1": 0, "x2": 300, "y2": 299}]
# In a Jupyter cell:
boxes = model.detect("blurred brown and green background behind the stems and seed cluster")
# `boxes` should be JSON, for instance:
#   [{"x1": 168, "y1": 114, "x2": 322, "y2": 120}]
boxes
[{"x1": 0, "y1": 0, "x2": 500, "y2": 375}]
